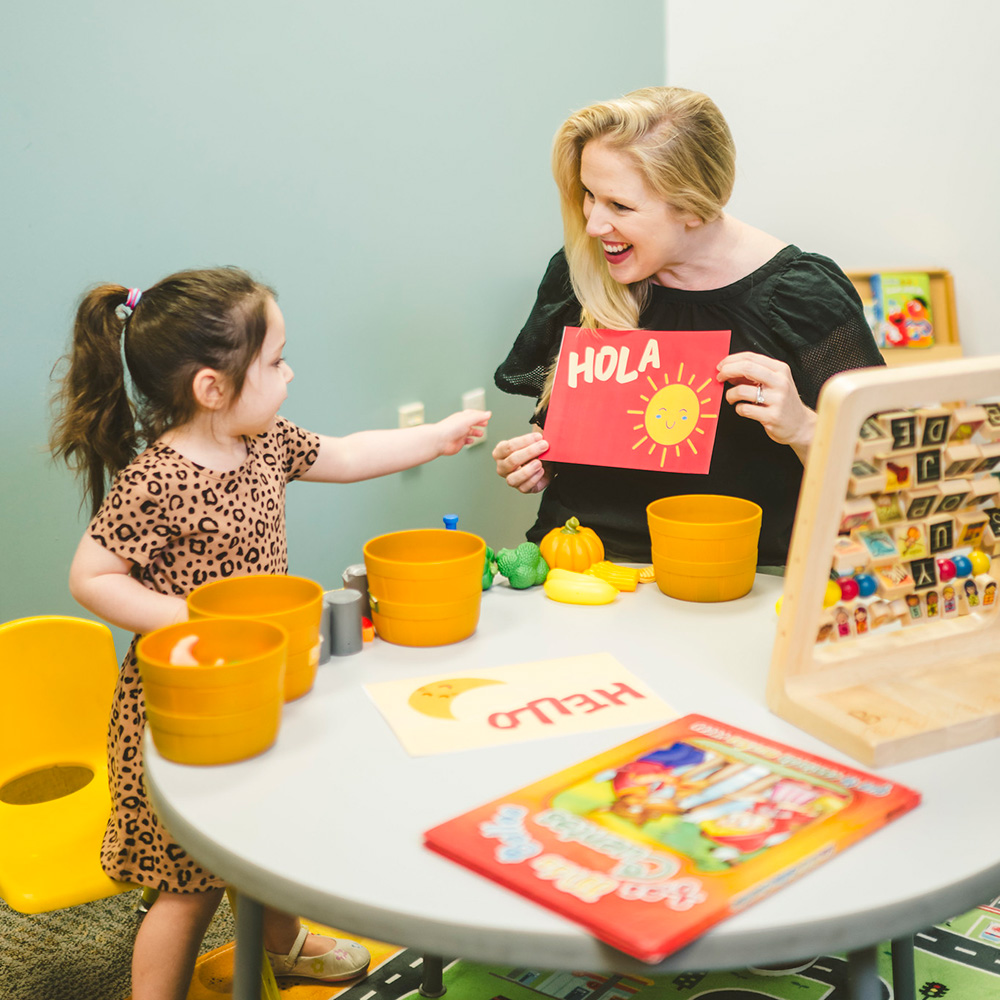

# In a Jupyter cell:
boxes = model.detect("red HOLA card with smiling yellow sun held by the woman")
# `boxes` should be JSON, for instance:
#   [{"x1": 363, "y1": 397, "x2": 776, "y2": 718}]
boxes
[{"x1": 545, "y1": 326, "x2": 731, "y2": 474}]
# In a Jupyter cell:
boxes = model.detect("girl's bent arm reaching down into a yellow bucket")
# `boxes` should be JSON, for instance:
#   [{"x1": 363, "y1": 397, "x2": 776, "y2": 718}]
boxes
[{"x1": 69, "y1": 535, "x2": 187, "y2": 632}]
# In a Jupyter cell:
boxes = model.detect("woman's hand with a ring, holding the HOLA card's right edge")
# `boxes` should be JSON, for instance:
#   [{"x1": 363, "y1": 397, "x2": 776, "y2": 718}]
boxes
[{"x1": 716, "y1": 351, "x2": 816, "y2": 462}]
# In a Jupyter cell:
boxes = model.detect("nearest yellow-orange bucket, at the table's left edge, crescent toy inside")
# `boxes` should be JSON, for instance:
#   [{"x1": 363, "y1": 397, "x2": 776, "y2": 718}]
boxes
[{"x1": 136, "y1": 618, "x2": 288, "y2": 764}]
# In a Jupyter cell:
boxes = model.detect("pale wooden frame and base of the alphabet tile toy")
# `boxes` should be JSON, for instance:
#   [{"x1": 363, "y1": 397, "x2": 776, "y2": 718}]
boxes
[{"x1": 767, "y1": 355, "x2": 1000, "y2": 767}]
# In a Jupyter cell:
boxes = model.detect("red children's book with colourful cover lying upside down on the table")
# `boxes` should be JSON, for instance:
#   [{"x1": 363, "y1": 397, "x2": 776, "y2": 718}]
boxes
[{"x1": 424, "y1": 715, "x2": 920, "y2": 963}]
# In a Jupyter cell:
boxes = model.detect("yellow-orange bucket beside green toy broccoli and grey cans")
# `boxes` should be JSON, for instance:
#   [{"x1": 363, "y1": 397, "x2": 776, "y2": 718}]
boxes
[{"x1": 364, "y1": 528, "x2": 486, "y2": 646}]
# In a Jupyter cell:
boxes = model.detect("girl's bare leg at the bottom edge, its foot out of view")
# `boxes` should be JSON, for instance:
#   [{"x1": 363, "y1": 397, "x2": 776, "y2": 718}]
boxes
[{"x1": 132, "y1": 889, "x2": 223, "y2": 1000}]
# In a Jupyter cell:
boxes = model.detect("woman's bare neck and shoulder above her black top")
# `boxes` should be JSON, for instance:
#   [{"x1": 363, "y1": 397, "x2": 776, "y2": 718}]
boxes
[{"x1": 652, "y1": 213, "x2": 787, "y2": 292}]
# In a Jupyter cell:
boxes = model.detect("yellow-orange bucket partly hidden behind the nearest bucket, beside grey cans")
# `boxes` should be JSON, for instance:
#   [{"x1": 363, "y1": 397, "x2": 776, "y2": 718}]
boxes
[{"x1": 187, "y1": 576, "x2": 323, "y2": 701}]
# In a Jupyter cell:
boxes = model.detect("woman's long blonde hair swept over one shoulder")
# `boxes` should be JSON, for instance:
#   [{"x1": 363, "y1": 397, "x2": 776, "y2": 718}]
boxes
[{"x1": 552, "y1": 87, "x2": 736, "y2": 330}]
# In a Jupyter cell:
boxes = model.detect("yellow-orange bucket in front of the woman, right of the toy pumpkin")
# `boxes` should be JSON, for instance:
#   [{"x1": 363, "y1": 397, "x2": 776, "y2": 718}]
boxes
[{"x1": 646, "y1": 494, "x2": 762, "y2": 602}]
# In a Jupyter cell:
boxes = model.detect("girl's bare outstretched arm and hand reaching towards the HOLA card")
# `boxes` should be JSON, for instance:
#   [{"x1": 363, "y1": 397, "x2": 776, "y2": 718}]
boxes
[{"x1": 302, "y1": 410, "x2": 491, "y2": 483}]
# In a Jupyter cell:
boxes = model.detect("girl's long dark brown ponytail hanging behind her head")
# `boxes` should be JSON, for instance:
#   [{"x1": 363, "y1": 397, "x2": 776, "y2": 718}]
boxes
[{"x1": 51, "y1": 285, "x2": 137, "y2": 515}]
